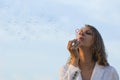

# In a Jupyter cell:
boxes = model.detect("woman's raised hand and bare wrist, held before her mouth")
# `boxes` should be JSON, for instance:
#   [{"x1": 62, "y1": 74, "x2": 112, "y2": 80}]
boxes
[{"x1": 67, "y1": 39, "x2": 80, "y2": 67}]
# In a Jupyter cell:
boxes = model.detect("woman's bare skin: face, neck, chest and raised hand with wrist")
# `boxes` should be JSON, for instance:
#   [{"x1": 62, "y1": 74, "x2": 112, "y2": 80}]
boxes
[{"x1": 67, "y1": 27, "x2": 95, "y2": 80}]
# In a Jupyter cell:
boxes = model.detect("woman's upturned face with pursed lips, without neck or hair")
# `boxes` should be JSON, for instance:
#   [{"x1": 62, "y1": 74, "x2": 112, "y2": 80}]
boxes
[{"x1": 77, "y1": 27, "x2": 93, "y2": 47}]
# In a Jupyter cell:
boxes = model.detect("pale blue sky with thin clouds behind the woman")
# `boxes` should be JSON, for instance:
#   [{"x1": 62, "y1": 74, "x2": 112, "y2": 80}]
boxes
[{"x1": 0, "y1": 0, "x2": 120, "y2": 80}]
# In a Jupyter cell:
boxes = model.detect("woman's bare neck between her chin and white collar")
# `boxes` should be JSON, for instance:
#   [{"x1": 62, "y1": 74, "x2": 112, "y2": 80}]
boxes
[{"x1": 79, "y1": 48, "x2": 95, "y2": 71}]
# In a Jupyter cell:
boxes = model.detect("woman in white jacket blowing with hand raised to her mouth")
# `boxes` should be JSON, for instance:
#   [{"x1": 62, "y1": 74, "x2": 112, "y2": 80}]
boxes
[{"x1": 60, "y1": 25, "x2": 119, "y2": 80}]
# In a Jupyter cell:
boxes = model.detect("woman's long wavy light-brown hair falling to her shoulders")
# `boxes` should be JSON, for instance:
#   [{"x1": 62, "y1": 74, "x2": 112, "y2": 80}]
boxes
[{"x1": 68, "y1": 24, "x2": 109, "y2": 66}]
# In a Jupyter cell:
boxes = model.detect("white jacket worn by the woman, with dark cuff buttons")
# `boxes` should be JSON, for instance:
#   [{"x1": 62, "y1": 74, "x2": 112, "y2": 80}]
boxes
[{"x1": 59, "y1": 63, "x2": 119, "y2": 80}]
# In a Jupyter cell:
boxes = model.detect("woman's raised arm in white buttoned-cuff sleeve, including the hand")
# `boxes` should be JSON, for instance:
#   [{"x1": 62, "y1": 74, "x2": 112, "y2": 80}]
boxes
[{"x1": 60, "y1": 39, "x2": 81, "y2": 80}]
